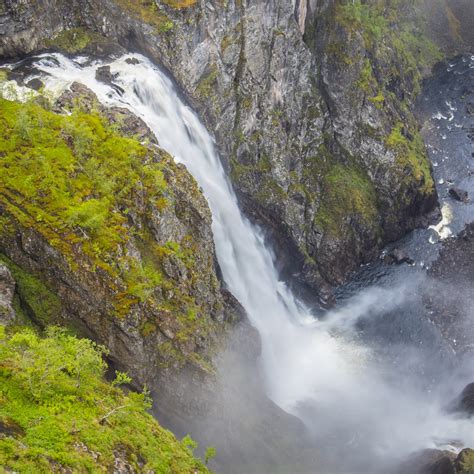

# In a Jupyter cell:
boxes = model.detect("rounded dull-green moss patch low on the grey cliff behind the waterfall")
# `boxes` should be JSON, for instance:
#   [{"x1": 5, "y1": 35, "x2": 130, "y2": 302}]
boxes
[{"x1": 315, "y1": 164, "x2": 378, "y2": 237}]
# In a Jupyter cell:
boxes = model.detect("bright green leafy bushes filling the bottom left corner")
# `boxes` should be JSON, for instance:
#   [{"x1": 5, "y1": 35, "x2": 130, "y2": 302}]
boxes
[{"x1": 0, "y1": 326, "x2": 208, "y2": 474}]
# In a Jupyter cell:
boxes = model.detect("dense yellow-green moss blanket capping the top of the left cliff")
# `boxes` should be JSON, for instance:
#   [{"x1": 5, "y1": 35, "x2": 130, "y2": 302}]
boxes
[{"x1": 0, "y1": 100, "x2": 167, "y2": 306}]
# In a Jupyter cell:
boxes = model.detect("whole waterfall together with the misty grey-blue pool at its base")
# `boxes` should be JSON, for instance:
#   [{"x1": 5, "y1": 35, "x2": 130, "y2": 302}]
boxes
[{"x1": 5, "y1": 54, "x2": 474, "y2": 472}]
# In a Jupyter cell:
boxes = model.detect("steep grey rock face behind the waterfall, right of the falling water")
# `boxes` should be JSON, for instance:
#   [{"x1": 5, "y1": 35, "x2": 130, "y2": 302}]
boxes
[{"x1": 0, "y1": 0, "x2": 467, "y2": 300}]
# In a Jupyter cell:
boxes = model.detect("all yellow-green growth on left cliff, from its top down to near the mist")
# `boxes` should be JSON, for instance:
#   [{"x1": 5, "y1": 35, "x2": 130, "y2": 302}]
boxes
[{"x1": 0, "y1": 99, "x2": 216, "y2": 370}]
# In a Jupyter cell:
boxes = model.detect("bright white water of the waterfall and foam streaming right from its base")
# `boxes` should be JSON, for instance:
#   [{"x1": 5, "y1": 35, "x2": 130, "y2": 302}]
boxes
[{"x1": 26, "y1": 55, "x2": 474, "y2": 470}]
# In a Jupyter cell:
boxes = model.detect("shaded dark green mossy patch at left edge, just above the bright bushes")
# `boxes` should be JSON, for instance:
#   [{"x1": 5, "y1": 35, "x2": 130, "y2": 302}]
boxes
[{"x1": 0, "y1": 253, "x2": 61, "y2": 326}]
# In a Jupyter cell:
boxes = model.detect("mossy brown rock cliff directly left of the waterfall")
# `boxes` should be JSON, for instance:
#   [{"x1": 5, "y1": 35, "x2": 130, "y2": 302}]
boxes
[{"x1": 0, "y1": 84, "x2": 237, "y2": 385}]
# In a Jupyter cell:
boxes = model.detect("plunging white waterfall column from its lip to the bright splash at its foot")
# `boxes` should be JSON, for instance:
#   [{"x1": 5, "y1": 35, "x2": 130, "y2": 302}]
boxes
[{"x1": 31, "y1": 51, "x2": 364, "y2": 410}]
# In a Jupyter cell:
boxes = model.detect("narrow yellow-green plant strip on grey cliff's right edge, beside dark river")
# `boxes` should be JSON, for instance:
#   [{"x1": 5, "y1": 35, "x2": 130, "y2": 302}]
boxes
[{"x1": 385, "y1": 123, "x2": 434, "y2": 195}]
